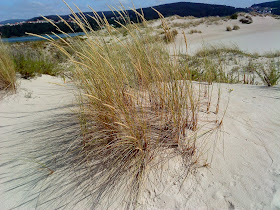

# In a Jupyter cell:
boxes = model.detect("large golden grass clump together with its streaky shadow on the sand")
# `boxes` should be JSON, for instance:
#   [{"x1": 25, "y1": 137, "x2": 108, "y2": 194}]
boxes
[{"x1": 0, "y1": 3, "x2": 222, "y2": 208}]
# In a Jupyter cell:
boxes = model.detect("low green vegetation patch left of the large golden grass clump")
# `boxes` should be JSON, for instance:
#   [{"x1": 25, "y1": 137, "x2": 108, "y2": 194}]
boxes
[{"x1": 11, "y1": 37, "x2": 77, "y2": 79}]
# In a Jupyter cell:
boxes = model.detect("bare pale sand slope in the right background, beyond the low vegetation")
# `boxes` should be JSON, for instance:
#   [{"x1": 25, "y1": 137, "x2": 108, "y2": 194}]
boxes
[{"x1": 166, "y1": 16, "x2": 280, "y2": 54}]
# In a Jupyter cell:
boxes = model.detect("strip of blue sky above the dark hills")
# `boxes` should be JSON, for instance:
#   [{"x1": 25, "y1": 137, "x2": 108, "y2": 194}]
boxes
[{"x1": 0, "y1": 0, "x2": 270, "y2": 21}]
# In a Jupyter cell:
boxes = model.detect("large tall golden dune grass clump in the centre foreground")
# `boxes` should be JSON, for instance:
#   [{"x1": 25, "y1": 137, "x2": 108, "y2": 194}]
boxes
[{"x1": 18, "y1": 2, "x2": 221, "y2": 208}]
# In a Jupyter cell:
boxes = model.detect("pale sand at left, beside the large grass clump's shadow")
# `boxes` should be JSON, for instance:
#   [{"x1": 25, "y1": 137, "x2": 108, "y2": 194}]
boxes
[{"x1": 0, "y1": 75, "x2": 74, "y2": 210}]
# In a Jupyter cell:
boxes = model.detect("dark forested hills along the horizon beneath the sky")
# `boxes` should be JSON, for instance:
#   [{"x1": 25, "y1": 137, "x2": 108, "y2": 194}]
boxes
[{"x1": 0, "y1": 2, "x2": 245, "y2": 38}]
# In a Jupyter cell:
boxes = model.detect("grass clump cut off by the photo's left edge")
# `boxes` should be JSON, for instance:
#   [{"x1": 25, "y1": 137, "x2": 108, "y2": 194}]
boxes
[{"x1": 0, "y1": 40, "x2": 16, "y2": 90}]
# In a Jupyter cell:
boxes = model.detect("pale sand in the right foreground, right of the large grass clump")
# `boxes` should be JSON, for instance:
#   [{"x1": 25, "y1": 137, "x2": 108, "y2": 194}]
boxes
[{"x1": 141, "y1": 85, "x2": 280, "y2": 209}]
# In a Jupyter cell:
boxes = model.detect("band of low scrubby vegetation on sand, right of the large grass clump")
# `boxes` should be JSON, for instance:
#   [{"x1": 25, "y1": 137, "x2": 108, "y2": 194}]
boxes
[{"x1": 181, "y1": 46, "x2": 280, "y2": 86}]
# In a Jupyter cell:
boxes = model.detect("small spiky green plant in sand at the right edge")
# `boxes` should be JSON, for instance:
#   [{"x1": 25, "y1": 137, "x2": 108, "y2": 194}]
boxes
[{"x1": 256, "y1": 61, "x2": 280, "y2": 87}]
